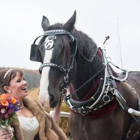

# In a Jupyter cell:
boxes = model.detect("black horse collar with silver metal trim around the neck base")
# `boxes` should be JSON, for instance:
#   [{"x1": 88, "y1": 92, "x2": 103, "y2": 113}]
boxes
[{"x1": 65, "y1": 49, "x2": 114, "y2": 116}]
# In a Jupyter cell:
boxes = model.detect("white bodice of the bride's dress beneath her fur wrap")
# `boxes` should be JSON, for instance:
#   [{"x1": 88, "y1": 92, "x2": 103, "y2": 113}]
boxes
[{"x1": 18, "y1": 116, "x2": 39, "y2": 140}]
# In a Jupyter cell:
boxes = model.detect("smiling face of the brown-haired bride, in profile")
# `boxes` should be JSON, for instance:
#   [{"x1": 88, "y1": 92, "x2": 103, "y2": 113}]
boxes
[{"x1": 8, "y1": 72, "x2": 28, "y2": 99}]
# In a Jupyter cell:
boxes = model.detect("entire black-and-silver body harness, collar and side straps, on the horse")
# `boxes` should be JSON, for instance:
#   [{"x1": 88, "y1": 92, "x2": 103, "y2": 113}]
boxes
[{"x1": 65, "y1": 48, "x2": 140, "y2": 140}]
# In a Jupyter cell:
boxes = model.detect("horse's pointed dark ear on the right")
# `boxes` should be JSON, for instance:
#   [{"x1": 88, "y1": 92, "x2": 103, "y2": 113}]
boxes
[{"x1": 63, "y1": 10, "x2": 76, "y2": 31}]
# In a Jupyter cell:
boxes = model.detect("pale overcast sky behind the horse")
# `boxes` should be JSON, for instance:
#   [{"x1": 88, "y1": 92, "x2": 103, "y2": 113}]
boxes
[{"x1": 0, "y1": 0, "x2": 140, "y2": 71}]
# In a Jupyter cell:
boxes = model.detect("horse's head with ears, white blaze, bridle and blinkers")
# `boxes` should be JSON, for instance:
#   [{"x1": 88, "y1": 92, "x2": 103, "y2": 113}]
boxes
[{"x1": 30, "y1": 11, "x2": 76, "y2": 107}]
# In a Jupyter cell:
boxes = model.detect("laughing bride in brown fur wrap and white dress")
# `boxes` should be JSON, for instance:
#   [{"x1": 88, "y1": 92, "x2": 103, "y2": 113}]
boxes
[{"x1": 0, "y1": 69, "x2": 67, "y2": 140}]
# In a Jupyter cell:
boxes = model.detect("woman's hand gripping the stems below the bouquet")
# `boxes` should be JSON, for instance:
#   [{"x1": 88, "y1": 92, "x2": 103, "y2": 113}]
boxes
[{"x1": 0, "y1": 129, "x2": 13, "y2": 140}]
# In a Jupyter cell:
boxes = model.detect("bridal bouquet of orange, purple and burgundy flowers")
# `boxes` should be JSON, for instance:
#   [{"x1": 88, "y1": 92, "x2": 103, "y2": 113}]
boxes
[{"x1": 0, "y1": 94, "x2": 20, "y2": 140}]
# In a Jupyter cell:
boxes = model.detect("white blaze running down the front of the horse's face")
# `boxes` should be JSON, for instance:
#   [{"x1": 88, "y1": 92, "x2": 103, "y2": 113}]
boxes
[{"x1": 38, "y1": 39, "x2": 53, "y2": 108}]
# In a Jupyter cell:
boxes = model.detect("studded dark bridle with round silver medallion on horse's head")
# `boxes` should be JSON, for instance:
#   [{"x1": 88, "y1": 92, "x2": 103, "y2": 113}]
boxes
[{"x1": 33, "y1": 29, "x2": 77, "y2": 95}]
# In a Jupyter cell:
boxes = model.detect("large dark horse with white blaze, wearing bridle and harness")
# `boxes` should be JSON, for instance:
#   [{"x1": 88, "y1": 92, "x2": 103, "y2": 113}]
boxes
[{"x1": 30, "y1": 11, "x2": 140, "y2": 140}]
